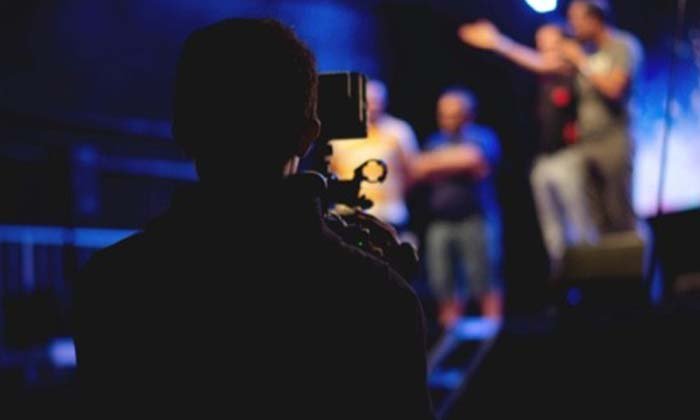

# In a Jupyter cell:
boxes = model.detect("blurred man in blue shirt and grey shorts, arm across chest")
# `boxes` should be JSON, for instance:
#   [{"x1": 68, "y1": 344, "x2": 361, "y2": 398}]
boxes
[{"x1": 414, "y1": 88, "x2": 502, "y2": 328}]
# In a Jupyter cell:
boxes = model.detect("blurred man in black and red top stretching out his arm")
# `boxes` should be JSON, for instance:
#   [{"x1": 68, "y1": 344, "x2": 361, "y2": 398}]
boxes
[{"x1": 459, "y1": 20, "x2": 595, "y2": 277}]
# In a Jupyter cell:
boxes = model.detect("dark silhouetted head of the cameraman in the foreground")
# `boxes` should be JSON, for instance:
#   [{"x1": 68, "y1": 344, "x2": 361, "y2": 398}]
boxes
[{"x1": 173, "y1": 19, "x2": 320, "y2": 184}]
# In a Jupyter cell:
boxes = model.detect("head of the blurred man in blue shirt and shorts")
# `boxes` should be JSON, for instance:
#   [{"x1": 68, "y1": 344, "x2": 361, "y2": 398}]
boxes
[{"x1": 437, "y1": 88, "x2": 476, "y2": 135}]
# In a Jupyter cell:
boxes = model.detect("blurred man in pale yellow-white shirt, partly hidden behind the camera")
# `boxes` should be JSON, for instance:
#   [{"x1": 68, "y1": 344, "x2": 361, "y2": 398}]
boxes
[{"x1": 331, "y1": 80, "x2": 418, "y2": 232}]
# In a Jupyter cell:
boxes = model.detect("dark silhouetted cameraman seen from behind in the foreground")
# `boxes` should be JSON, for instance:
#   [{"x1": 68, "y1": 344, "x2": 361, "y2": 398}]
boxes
[{"x1": 76, "y1": 19, "x2": 432, "y2": 419}]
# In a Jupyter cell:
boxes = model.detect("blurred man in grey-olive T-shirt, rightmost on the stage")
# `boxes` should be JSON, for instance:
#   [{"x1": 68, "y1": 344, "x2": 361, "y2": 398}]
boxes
[{"x1": 562, "y1": 0, "x2": 643, "y2": 234}]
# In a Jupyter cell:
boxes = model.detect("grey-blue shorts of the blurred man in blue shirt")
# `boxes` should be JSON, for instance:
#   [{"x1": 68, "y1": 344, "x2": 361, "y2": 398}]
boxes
[{"x1": 426, "y1": 215, "x2": 500, "y2": 302}]
